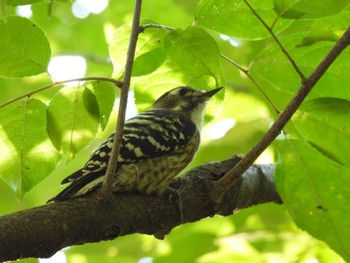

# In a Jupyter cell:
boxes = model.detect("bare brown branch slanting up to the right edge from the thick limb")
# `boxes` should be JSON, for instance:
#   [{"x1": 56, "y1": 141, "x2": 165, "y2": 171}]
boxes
[{"x1": 217, "y1": 27, "x2": 350, "y2": 194}]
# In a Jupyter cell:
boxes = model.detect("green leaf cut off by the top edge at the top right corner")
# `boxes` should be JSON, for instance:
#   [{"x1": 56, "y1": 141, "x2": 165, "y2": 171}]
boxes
[{"x1": 274, "y1": 0, "x2": 349, "y2": 19}]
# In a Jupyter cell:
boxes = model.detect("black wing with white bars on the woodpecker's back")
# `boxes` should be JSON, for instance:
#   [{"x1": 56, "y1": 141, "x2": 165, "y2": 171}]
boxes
[{"x1": 49, "y1": 110, "x2": 198, "y2": 200}]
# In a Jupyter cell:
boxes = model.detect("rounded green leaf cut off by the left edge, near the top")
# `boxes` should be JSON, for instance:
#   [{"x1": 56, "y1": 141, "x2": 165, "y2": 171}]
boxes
[{"x1": 0, "y1": 17, "x2": 51, "y2": 78}]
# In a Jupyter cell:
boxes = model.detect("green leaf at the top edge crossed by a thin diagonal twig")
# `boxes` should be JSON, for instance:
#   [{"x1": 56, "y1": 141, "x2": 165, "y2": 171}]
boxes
[{"x1": 194, "y1": 0, "x2": 291, "y2": 40}]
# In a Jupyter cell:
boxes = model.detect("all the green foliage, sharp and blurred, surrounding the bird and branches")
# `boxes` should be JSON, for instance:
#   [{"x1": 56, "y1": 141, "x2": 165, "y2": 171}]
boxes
[{"x1": 0, "y1": 0, "x2": 350, "y2": 263}]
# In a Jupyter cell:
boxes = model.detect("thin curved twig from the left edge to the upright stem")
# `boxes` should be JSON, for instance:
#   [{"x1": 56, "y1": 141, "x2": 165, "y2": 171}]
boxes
[{"x1": 0, "y1": 77, "x2": 122, "y2": 108}]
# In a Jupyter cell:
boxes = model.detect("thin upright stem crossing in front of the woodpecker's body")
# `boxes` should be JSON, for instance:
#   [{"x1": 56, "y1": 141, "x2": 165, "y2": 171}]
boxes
[{"x1": 101, "y1": 0, "x2": 142, "y2": 195}]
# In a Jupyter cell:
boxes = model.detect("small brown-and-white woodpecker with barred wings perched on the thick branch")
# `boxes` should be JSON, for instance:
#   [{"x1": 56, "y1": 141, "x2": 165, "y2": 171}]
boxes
[{"x1": 49, "y1": 86, "x2": 221, "y2": 201}]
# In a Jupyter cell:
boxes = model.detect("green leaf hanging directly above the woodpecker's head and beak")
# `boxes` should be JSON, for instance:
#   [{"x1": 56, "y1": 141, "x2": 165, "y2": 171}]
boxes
[{"x1": 165, "y1": 27, "x2": 223, "y2": 86}]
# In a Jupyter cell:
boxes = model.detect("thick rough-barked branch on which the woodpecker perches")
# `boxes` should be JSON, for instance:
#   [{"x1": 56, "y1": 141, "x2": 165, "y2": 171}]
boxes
[{"x1": 0, "y1": 157, "x2": 281, "y2": 261}]
